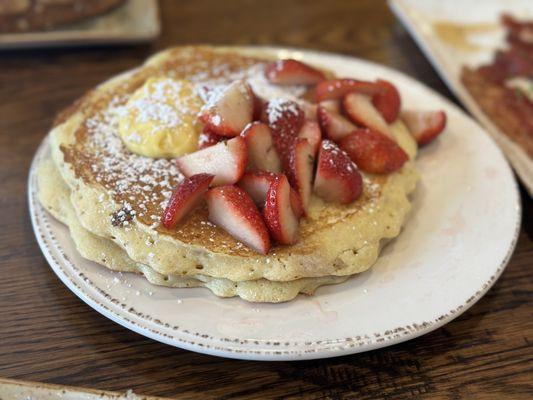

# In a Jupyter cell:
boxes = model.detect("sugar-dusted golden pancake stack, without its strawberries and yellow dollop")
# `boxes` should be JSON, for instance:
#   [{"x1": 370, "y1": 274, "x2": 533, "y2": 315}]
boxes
[{"x1": 39, "y1": 47, "x2": 417, "y2": 302}]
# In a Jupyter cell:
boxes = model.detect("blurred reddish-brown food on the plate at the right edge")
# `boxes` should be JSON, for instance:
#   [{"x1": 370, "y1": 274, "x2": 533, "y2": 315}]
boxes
[{"x1": 461, "y1": 15, "x2": 533, "y2": 158}]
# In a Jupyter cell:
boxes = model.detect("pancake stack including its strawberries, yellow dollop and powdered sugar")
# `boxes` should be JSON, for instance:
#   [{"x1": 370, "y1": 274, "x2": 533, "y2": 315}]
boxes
[{"x1": 39, "y1": 47, "x2": 446, "y2": 302}]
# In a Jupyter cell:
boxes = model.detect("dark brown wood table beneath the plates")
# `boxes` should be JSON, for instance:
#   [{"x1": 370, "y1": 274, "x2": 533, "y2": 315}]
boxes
[{"x1": 0, "y1": 0, "x2": 533, "y2": 399}]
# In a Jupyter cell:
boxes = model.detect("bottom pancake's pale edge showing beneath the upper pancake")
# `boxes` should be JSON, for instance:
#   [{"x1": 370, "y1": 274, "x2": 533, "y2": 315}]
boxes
[{"x1": 37, "y1": 159, "x2": 348, "y2": 303}]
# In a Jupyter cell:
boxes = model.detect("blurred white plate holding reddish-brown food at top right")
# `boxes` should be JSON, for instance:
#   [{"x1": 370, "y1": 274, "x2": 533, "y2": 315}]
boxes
[{"x1": 389, "y1": 0, "x2": 533, "y2": 196}]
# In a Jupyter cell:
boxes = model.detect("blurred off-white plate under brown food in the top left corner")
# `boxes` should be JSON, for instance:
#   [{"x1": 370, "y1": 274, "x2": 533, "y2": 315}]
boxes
[{"x1": 0, "y1": 0, "x2": 161, "y2": 50}]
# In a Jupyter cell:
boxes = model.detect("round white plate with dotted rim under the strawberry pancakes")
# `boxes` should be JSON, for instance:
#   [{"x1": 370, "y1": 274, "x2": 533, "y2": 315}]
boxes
[{"x1": 29, "y1": 49, "x2": 520, "y2": 360}]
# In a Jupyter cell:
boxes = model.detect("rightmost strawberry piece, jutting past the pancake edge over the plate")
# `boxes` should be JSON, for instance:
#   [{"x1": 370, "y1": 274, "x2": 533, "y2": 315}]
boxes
[{"x1": 402, "y1": 110, "x2": 446, "y2": 146}]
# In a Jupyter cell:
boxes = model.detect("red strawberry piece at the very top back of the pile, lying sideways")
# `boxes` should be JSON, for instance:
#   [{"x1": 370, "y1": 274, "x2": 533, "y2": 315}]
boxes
[{"x1": 265, "y1": 59, "x2": 326, "y2": 85}]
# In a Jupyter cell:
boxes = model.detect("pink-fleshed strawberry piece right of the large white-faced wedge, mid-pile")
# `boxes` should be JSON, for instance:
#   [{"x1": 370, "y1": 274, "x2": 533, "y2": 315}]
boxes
[{"x1": 241, "y1": 122, "x2": 281, "y2": 172}]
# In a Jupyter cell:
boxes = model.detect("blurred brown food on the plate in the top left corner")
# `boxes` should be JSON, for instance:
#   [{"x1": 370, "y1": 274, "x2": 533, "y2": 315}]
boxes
[{"x1": 0, "y1": 0, "x2": 125, "y2": 33}]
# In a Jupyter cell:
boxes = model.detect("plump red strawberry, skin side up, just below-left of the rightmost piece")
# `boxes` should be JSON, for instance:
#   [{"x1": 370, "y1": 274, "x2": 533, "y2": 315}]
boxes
[{"x1": 339, "y1": 128, "x2": 409, "y2": 174}]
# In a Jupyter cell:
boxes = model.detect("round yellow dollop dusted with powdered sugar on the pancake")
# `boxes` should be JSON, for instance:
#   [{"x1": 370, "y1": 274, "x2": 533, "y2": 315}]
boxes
[{"x1": 119, "y1": 77, "x2": 204, "y2": 158}]
